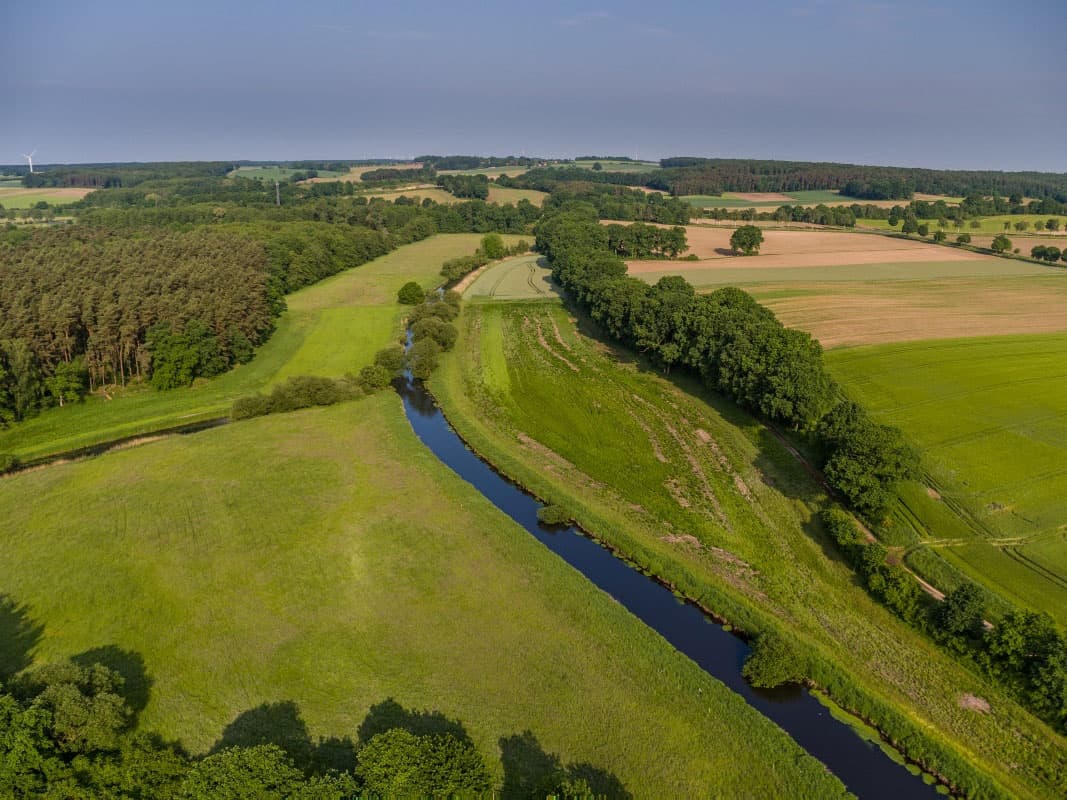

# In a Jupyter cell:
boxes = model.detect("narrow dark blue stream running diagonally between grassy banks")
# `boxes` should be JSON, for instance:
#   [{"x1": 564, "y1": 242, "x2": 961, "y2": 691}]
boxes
[{"x1": 394, "y1": 379, "x2": 941, "y2": 800}]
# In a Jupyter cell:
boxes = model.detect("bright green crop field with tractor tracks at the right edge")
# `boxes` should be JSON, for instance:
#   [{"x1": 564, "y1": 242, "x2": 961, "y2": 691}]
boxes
[{"x1": 828, "y1": 334, "x2": 1067, "y2": 624}]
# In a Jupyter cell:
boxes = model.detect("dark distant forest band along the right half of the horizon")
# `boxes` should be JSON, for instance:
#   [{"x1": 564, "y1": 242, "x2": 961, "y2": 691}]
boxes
[{"x1": 516, "y1": 158, "x2": 1067, "y2": 203}]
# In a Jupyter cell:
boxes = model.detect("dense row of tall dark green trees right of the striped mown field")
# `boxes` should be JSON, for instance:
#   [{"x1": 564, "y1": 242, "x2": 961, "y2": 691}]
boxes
[{"x1": 535, "y1": 204, "x2": 918, "y2": 515}]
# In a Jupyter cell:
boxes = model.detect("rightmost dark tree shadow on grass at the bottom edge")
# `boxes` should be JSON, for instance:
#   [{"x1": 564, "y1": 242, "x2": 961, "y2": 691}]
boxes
[{"x1": 499, "y1": 731, "x2": 633, "y2": 800}]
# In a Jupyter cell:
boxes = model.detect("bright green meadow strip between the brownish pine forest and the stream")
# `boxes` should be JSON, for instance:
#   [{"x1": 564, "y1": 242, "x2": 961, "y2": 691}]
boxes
[{"x1": 0, "y1": 234, "x2": 522, "y2": 460}]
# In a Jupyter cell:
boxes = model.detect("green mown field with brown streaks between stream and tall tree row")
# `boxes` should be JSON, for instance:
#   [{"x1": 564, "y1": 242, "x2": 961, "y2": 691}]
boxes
[{"x1": 431, "y1": 301, "x2": 1067, "y2": 797}]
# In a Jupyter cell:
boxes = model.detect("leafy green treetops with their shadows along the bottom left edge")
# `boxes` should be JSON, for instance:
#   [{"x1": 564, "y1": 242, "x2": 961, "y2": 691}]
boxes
[{"x1": 0, "y1": 654, "x2": 628, "y2": 800}]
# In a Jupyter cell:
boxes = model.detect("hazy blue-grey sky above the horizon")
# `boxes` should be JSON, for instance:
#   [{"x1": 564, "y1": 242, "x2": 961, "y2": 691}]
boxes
[{"x1": 0, "y1": 0, "x2": 1067, "y2": 172}]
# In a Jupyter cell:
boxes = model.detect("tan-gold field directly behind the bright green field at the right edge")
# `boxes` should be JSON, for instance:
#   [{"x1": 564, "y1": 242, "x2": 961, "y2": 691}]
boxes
[{"x1": 749, "y1": 270, "x2": 1067, "y2": 348}]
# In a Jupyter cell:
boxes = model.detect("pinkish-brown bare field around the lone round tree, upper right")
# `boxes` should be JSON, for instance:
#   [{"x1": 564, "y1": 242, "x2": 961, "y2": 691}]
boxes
[{"x1": 630, "y1": 225, "x2": 991, "y2": 272}]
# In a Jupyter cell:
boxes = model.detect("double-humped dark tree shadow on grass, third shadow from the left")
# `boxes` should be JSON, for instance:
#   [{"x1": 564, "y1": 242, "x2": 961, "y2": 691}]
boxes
[{"x1": 211, "y1": 700, "x2": 355, "y2": 774}]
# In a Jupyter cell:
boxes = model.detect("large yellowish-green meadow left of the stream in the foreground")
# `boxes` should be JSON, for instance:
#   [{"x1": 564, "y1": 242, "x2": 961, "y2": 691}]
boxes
[{"x1": 0, "y1": 391, "x2": 842, "y2": 797}]
